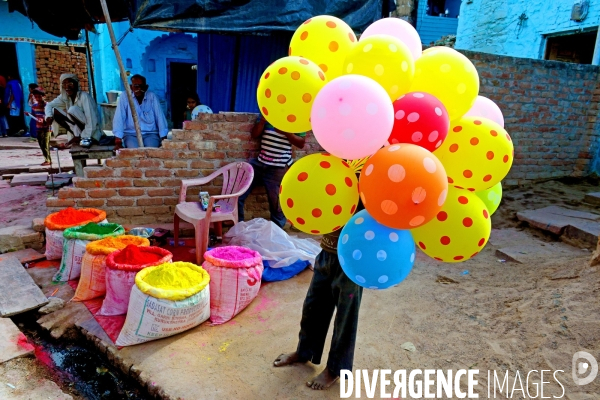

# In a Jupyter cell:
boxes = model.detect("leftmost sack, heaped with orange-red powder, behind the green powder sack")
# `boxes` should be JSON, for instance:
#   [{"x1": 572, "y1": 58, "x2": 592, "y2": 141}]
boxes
[{"x1": 44, "y1": 207, "x2": 107, "y2": 260}]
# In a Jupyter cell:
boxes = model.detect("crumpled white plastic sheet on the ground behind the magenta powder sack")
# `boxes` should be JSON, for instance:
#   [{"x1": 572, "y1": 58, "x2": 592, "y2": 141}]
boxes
[{"x1": 225, "y1": 218, "x2": 321, "y2": 268}]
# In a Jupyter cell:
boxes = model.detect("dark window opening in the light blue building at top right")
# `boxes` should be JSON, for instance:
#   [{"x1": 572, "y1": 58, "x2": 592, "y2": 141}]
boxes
[{"x1": 544, "y1": 31, "x2": 598, "y2": 64}]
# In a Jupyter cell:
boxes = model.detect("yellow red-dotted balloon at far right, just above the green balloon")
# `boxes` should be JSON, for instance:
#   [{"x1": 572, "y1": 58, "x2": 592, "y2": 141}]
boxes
[{"x1": 433, "y1": 117, "x2": 514, "y2": 192}]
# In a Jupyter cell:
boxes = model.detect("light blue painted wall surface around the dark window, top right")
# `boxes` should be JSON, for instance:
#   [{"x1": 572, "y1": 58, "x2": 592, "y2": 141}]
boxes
[{"x1": 456, "y1": 0, "x2": 600, "y2": 59}]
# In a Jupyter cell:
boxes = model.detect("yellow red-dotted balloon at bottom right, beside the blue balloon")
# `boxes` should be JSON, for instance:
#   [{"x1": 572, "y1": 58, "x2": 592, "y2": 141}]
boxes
[{"x1": 410, "y1": 188, "x2": 492, "y2": 263}]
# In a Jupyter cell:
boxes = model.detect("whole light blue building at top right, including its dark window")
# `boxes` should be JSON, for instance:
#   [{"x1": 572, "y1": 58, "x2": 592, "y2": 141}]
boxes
[{"x1": 456, "y1": 0, "x2": 600, "y2": 65}]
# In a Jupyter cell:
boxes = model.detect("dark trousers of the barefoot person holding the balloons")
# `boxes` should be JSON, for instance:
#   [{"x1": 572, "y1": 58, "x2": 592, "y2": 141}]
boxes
[{"x1": 297, "y1": 250, "x2": 363, "y2": 376}]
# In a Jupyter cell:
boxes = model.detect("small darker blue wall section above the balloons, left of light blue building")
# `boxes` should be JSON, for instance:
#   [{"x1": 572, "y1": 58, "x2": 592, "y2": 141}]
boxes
[{"x1": 417, "y1": 0, "x2": 462, "y2": 45}]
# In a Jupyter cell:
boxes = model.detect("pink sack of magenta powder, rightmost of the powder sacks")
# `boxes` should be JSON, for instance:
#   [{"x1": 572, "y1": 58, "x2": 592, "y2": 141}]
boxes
[{"x1": 202, "y1": 246, "x2": 264, "y2": 325}]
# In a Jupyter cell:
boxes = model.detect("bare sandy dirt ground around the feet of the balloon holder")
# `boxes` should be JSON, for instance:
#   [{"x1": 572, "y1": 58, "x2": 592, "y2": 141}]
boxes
[{"x1": 0, "y1": 179, "x2": 600, "y2": 400}]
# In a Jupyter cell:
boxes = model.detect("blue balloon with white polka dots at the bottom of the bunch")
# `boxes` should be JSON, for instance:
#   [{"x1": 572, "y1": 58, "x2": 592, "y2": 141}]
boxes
[{"x1": 338, "y1": 210, "x2": 415, "y2": 289}]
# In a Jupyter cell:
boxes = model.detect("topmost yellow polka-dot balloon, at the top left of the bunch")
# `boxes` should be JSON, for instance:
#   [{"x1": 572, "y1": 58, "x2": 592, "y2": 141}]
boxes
[{"x1": 289, "y1": 15, "x2": 357, "y2": 80}]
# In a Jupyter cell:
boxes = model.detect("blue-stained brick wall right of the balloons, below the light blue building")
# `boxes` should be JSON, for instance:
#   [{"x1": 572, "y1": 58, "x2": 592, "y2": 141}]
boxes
[{"x1": 461, "y1": 51, "x2": 600, "y2": 186}]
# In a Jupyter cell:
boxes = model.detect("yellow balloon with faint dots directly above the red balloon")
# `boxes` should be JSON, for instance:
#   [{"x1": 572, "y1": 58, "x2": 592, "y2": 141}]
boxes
[{"x1": 410, "y1": 46, "x2": 479, "y2": 121}]
